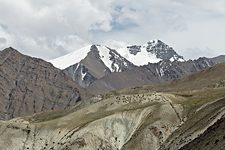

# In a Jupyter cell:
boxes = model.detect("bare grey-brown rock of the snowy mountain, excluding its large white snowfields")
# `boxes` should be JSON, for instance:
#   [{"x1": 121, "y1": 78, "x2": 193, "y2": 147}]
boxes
[{"x1": 60, "y1": 40, "x2": 225, "y2": 91}]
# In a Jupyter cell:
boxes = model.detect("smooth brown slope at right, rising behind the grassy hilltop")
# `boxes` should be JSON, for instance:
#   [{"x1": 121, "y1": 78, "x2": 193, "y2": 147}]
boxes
[{"x1": 117, "y1": 63, "x2": 225, "y2": 94}]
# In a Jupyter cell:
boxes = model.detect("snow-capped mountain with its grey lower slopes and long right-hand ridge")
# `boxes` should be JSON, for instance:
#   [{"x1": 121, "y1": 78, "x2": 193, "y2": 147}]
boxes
[{"x1": 50, "y1": 40, "x2": 225, "y2": 94}]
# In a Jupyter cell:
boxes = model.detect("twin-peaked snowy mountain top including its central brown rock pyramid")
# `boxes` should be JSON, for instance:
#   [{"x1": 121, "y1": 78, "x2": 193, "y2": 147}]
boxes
[{"x1": 50, "y1": 40, "x2": 184, "y2": 87}]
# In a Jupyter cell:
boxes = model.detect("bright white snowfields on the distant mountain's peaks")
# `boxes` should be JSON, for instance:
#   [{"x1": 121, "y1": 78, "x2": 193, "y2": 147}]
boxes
[{"x1": 49, "y1": 40, "x2": 184, "y2": 72}]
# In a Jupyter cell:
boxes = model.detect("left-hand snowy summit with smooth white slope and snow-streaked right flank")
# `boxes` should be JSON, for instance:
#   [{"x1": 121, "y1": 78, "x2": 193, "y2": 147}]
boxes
[{"x1": 49, "y1": 45, "x2": 134, "y2": 72}]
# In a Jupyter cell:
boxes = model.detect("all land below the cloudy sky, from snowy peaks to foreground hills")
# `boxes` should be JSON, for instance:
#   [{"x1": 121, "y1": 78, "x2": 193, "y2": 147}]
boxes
[{"x1": 0, "y1": 40, "x2": 225, "y2": 150}]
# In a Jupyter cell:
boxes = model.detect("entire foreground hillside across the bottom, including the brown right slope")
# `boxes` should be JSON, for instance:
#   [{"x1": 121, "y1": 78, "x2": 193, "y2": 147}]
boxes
[{"x1": 0, "y1": 60, "x2": 225, "y2": 150}]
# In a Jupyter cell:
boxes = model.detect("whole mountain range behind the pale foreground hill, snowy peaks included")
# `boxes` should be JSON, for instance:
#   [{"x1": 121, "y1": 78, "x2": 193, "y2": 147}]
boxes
[{"x1": 0, "y1": 40, "x2": 225, "y2": 120}]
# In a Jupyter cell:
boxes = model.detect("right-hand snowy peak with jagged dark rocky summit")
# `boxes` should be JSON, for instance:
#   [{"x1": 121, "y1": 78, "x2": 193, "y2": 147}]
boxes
[{"x1": 117, "y1": 40, "x2": 184, "y2": 66}]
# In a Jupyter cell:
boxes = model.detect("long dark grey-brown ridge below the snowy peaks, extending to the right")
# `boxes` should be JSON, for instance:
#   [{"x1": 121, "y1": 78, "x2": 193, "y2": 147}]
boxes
[{"x1": 88, "y1": 57, "x2": 225, "y2": 93}]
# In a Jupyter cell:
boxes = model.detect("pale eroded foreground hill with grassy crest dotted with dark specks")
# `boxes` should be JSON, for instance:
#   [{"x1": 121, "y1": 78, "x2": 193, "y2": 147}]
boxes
[{"x1": 0, "y1": 93, "x2": 185, "y2": 150}]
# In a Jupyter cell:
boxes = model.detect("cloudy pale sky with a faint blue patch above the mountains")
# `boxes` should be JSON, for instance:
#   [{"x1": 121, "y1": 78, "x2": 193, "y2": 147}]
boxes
[{"x1": 0, "y1": 0, "x2": 225, "y2": 60}]
